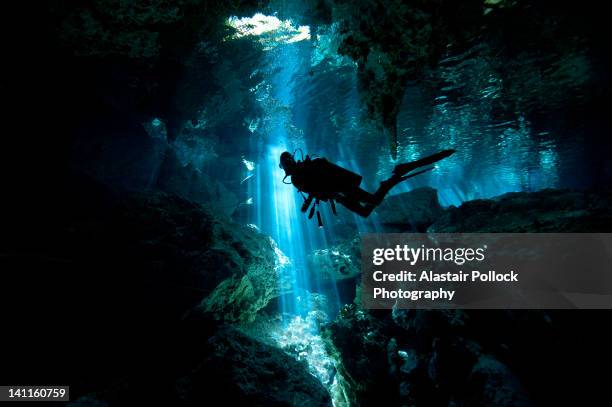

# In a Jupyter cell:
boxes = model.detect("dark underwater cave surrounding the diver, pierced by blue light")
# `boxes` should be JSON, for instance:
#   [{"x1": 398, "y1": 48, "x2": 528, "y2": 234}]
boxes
[{"x1": 0, "y1": 0, "x2": 612, "y2": 407}]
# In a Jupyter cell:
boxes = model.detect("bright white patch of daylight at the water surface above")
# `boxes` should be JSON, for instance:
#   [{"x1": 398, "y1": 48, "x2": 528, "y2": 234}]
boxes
[{"x1": 227, "y1": 13, "x2": 310, "y2": 49}]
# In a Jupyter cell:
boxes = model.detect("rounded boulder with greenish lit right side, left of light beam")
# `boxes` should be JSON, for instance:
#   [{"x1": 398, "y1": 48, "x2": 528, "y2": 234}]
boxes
[{"x1": 111, "y1": 186, "x2": 290, "y2": 321}]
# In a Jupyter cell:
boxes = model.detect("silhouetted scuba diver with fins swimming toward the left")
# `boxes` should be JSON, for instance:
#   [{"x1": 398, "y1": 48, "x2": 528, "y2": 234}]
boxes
[{"x1": 279, "y1": 149, "x2": 455, "y2": 226}]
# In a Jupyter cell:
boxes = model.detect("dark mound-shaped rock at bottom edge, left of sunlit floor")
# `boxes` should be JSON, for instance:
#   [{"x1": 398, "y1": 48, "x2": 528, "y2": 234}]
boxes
[{"x1": 178, "y1": 328, "x2": 331, "y2": 406}]
